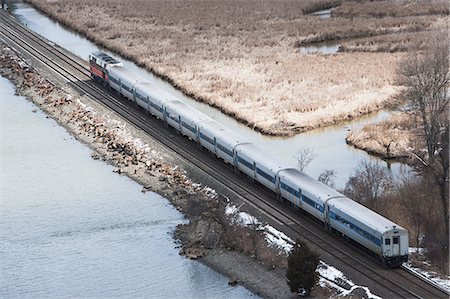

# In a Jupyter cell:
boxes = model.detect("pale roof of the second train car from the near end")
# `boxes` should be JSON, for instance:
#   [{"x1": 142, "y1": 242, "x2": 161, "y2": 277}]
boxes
[{"x1": 279, "y1": 168, "x2": 345, "y2": 201}]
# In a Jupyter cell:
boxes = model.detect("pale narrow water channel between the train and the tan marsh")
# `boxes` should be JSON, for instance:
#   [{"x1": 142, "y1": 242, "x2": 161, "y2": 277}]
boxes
[{"x1": 10, "y1": 0, "x2": 409, "y2": 188}]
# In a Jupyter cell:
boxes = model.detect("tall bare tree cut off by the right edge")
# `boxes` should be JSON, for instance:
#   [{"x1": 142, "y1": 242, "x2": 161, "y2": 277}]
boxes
[{"x1": 398, "y1": 31, "x2": 450, "y2": 236}]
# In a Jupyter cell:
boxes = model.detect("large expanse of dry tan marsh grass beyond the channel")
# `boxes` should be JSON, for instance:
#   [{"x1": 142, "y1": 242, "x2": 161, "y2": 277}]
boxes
[{"x1": 28, "y1": 0, "x2": 449, "y2": 135}]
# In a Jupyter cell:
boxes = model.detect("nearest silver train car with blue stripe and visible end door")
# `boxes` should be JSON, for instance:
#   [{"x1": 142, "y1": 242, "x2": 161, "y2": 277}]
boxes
[{"x1": 327, "y1": 197, "x2": 409, "y2": 266}]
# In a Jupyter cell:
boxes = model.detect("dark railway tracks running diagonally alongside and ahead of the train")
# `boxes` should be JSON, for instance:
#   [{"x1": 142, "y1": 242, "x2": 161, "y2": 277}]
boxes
[{"x1": 0, "y1": 11, "x2": 449, "y2": 298}]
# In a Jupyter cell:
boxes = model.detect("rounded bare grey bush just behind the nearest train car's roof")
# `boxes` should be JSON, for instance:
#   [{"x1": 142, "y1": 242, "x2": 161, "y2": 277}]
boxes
[{"x1": 344, "y1": 160, "x2": 393, "y2": 208}]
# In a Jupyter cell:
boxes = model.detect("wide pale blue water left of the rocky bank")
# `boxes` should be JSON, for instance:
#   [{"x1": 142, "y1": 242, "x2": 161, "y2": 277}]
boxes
[{"x1": 0, "y1": 77, "x2": 256, "y2": 298}]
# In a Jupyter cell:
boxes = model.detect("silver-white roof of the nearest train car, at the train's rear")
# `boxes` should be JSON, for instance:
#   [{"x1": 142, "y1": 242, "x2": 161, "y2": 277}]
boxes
[{"x1": 328, "y1": 197, "x2": 406, "y2": 233}]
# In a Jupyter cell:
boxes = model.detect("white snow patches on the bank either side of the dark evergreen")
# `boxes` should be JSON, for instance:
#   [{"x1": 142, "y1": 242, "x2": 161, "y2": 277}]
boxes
[{"x1": 225, "y1": 204, "x2": 381, "y2": 299}]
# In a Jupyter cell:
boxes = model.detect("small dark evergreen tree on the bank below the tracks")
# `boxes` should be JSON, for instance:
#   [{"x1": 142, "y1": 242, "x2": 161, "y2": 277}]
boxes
[{"x1": 286, "y1": 240, "x2": 319, "y2": 294}]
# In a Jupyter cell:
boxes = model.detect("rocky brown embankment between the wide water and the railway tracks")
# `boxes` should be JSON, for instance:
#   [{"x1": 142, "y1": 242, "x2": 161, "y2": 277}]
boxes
[{"x1": 0, "y1": 43, "x2": 298, "y2": 298}]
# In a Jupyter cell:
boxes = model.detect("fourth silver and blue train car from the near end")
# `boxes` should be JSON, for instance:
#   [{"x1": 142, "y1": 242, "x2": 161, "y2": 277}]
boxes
[{"x1": 199, "y1": 119, "x2": 249, "y2": 166}]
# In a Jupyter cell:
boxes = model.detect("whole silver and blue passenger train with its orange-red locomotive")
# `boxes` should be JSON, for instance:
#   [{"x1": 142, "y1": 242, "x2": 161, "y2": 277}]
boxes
[{"x1": 89, "y1": 51, "x2": 409, "y2": 267}]
